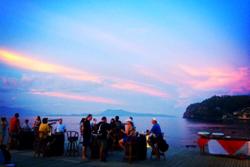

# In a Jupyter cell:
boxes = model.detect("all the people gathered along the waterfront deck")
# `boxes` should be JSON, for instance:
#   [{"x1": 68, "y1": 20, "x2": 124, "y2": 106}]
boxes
[{"x1": 0, "y1": 113, "x2": 165, "y2": 161}]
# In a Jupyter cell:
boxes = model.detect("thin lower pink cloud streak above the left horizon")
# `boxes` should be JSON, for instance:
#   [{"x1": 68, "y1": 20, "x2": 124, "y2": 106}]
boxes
[{"x1": 30, "y1": 90, "x2": 121, "y2": 105}]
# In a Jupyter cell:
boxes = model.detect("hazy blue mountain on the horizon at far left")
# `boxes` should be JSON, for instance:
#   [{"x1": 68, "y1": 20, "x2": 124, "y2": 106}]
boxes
[{"x1": 0, "y1": 106, "x2": 46, "y2": 117}]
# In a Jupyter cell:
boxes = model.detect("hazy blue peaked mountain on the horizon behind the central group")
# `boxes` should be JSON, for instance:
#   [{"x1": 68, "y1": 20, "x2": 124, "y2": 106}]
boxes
[{"x1": 97, "y1": 109, "x2": 173, "y2": 117}]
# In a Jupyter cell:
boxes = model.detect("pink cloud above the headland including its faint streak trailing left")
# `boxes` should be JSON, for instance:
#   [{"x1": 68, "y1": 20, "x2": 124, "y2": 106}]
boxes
[{"x1": 137, "y1": 65, "x2": 250, "y2": 98}]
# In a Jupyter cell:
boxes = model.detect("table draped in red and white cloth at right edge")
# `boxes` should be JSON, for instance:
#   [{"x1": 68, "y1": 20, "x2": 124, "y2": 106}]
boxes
[{"x1": 198, "y1": 135, "x2": 250, "y2": 156}]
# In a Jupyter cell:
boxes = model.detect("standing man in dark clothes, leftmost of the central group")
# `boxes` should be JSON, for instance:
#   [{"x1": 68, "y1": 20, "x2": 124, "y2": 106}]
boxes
[{"x1": 82, "y1": 114, "x2": 92, "y2": 160}]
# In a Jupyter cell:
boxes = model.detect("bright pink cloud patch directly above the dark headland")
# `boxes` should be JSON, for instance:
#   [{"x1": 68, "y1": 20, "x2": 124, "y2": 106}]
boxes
[{"x1": 179, "y1": 65, "x2": 250, "y2": 94}]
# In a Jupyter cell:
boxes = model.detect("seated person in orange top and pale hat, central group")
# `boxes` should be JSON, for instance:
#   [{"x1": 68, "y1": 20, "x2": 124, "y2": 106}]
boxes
[{"x1": 119, "y1": 119, "x2": 135, "y2": 149}]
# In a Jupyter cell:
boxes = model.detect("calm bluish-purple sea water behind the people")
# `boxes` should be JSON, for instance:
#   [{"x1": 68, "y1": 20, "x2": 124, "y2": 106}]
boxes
[{"x1": 19, "y1": 116, "x2": 250, "y2": 146}]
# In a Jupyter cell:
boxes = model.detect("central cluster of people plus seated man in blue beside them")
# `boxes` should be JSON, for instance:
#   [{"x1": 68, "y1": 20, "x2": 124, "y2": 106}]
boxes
[{"x1": 80, "y1": 114, "x2": 163, "y2": 161}]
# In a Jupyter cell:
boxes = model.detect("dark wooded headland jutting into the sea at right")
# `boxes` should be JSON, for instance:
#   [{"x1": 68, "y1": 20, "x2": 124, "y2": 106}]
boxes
[{"x1": 183, "y1": 95, "x2": 250, "y2": 121}]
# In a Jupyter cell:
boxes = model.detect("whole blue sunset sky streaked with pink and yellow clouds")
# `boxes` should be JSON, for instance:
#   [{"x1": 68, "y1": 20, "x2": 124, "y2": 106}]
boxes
[{"x1": 0, "y1": 0, "x2": 250, "y2": 116}]
